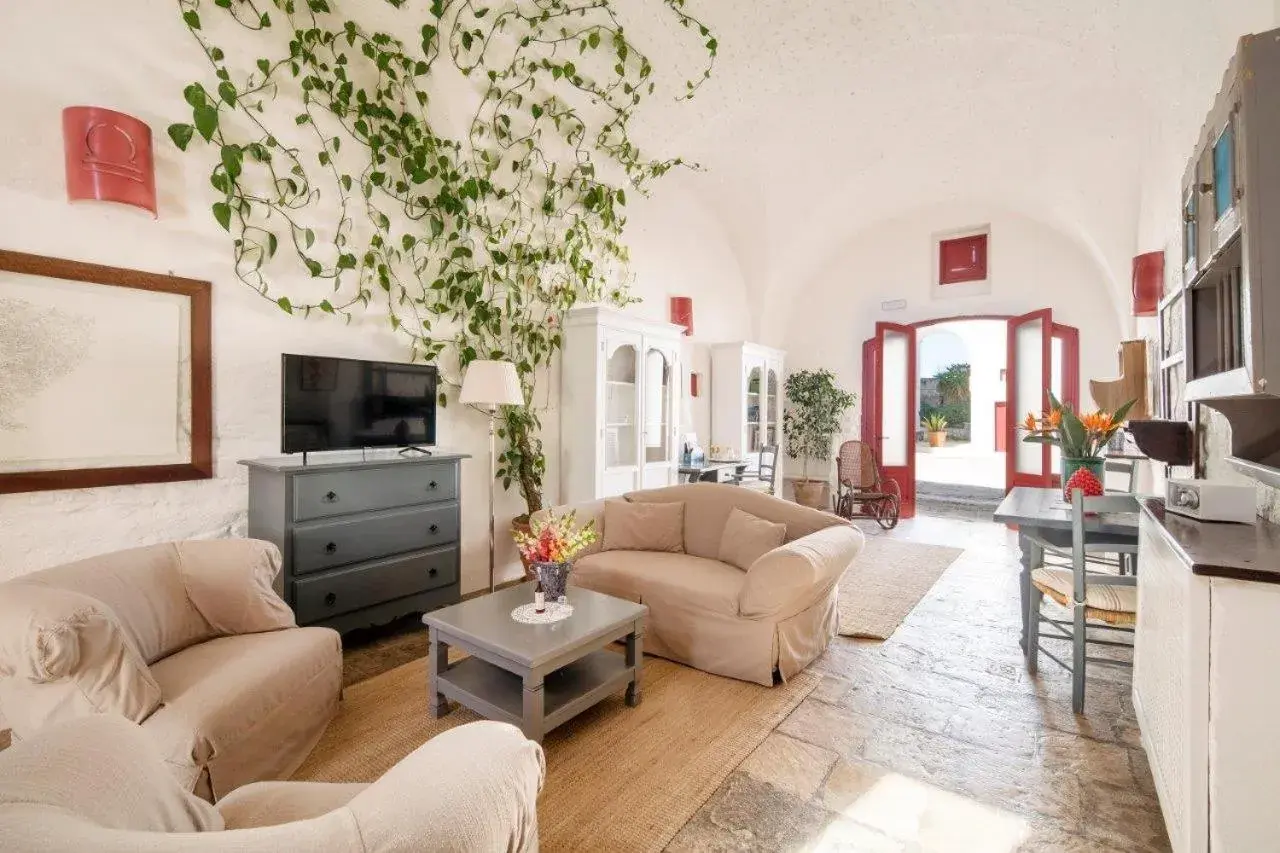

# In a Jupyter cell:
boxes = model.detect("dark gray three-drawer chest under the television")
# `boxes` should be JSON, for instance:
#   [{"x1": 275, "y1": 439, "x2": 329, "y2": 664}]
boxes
[{"x1": 241, "y1": 453, "x2": 466, "y2": 633}]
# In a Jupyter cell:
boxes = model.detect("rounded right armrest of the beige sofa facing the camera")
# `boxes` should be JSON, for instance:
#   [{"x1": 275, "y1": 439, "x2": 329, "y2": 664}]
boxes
[{"x1": 739, "y1": 524, "x2": 865, "y2": 619}]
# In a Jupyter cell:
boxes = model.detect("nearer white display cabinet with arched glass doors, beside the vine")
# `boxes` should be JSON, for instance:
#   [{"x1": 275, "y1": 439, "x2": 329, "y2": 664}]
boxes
[{"x1": 559, "y1": 306, "x2": 684, "y2": 503}]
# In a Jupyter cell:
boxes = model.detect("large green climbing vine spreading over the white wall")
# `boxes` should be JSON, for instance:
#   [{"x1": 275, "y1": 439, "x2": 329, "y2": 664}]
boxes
[{"x1": 169, "y1": 0, "x2": 718, "y2": 512}]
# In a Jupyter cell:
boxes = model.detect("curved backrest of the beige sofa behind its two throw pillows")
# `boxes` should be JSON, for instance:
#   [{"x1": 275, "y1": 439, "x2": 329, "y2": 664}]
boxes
[{"x1": 626, "y1": 483, "x2": 847, "y2": 560}]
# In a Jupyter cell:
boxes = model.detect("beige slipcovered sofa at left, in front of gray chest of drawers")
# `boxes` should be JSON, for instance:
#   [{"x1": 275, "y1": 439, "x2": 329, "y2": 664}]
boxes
[{"x1": 0, "y1": 539, "x2": 342, "y2": 800}]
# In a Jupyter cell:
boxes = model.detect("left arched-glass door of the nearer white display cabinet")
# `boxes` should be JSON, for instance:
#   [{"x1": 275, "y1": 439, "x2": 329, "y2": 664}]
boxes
[{"x1": 600, "y1": 329, "x2": 643, "y2": 497}]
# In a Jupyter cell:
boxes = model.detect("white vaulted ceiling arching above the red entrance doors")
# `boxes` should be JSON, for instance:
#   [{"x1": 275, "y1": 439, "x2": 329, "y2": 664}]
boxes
[{"x1": 626, "y1": 0, "x2": 1280, "y2": 333}]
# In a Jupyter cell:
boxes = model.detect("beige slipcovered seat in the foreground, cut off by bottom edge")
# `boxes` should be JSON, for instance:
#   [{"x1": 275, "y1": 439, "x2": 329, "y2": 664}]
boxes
[{"x1": 0, "y1": 716, "x2": 543, "y2": 853}]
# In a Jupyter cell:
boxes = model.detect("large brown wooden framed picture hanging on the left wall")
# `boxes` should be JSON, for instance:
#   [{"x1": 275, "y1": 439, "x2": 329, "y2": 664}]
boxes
[{"x1": 0, "y1": 250, "x2": 214, "y2": 494}]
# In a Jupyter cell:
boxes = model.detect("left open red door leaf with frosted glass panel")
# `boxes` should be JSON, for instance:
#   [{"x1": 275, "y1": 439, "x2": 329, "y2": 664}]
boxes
[{"x1": 872, "y1": 323, "x2": 919, "y2": 519}]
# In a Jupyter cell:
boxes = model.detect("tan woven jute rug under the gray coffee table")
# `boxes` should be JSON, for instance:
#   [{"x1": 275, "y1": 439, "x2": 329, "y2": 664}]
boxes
[{"x1": 294, "y1": 648, "x2": 819, "y2": 853}]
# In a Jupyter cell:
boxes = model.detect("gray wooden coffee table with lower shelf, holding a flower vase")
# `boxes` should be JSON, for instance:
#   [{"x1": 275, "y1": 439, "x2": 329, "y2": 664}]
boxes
[{"x1": 422, "y1": 583, "x2": 649, "y2": 742}]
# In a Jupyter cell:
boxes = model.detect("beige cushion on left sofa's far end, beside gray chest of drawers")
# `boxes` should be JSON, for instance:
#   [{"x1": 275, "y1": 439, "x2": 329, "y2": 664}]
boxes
[{"x1": 174, "y1": 539, "x2": 297, "y2": 634}]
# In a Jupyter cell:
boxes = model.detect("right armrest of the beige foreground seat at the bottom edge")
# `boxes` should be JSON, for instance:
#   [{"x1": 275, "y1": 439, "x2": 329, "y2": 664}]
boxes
[{"x1": 347, "y1": 720, "x2": 545, "y2": 853}]
